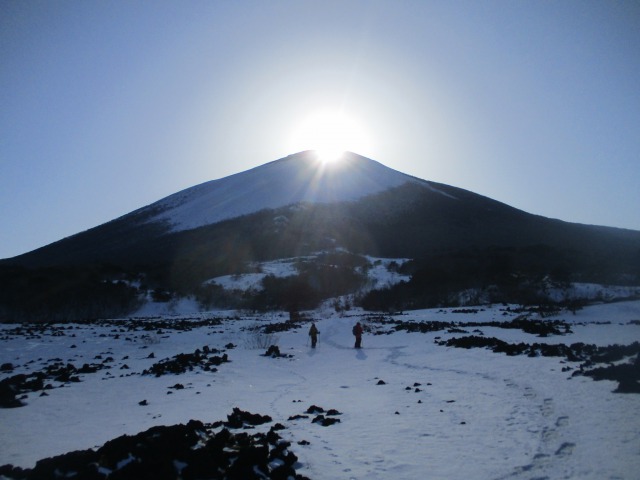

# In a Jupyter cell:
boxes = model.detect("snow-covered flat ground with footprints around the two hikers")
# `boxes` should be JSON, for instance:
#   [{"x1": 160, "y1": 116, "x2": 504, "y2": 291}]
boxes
[{"x1": 0, "y1": 301, "x2": 640, "y2": 480}]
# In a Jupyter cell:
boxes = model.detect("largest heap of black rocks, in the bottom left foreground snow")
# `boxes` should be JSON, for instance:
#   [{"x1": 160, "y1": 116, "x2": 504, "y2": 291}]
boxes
[{"x1": 0, "y1": 412, "x2": 309, "y2": 480}]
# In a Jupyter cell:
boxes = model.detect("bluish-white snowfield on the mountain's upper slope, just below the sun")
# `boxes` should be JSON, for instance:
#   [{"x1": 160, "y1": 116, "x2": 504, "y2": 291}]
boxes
[{"x1": 147, "y1": 152, "x2": 450, "y2": 231}]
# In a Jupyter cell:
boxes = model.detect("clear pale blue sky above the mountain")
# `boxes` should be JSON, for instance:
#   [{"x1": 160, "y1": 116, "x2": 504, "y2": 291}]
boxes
[{"x1": 0, "y1": 0, "x2": 640, "y2": 258}]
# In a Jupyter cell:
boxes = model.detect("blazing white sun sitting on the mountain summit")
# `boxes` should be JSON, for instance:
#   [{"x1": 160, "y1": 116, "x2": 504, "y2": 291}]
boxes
[{"x1": 290, "y1": 110, "x2": 370, "y2": 163}]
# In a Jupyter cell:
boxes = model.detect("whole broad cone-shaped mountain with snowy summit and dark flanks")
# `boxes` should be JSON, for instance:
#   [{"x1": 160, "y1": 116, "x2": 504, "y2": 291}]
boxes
[{"x1": 0, "y1": 152, "x2": 640, "y2": 318}]
